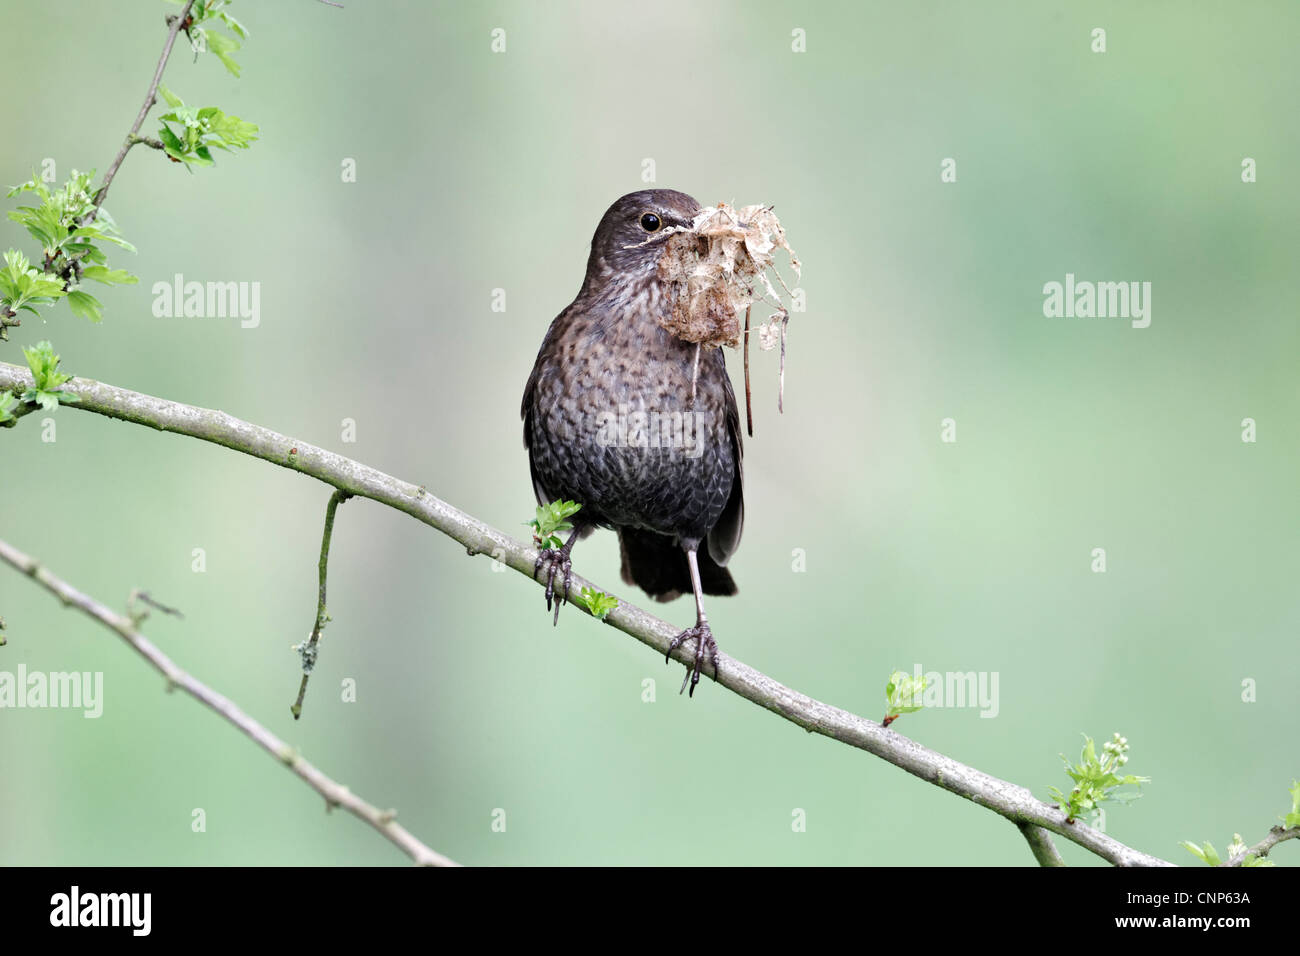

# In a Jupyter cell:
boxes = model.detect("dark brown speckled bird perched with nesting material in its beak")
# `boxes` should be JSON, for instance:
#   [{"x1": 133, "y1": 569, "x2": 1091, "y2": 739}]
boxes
[{"x1": 520, "y1": 189, "x2": 745, "y2": 697}]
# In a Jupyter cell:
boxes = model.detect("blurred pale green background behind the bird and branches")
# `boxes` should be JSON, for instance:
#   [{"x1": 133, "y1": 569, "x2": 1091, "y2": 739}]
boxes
[{"x1": 0, "y1": 0, "x2": 1300, "y2": 865}]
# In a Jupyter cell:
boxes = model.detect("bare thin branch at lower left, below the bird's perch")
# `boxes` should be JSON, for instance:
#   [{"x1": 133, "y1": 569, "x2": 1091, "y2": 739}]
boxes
[{"x1": 0, "y1": 541, "x2": 456, "y2": 866}]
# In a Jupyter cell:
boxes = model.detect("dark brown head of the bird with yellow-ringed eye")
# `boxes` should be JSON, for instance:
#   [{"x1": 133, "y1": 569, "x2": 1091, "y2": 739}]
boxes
[{"x1": 584, "y1": 189, "x2": 699, "y2": 290}]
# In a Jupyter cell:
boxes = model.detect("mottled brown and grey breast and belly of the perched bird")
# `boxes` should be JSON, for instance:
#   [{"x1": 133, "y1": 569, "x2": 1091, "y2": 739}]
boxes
[{"x1": 530, "y1": 282, "x2": 736, "y2": 532}]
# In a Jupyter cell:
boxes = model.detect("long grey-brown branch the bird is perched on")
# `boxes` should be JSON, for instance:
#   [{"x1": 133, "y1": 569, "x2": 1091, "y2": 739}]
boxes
[{"x1": 0, "y1": 363, "x2": 1173, "y2": 866}]
